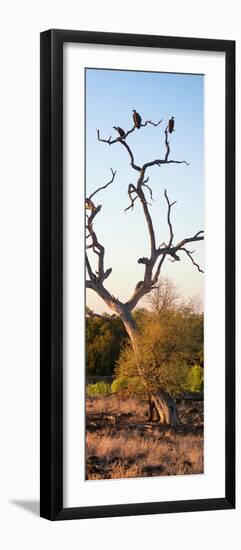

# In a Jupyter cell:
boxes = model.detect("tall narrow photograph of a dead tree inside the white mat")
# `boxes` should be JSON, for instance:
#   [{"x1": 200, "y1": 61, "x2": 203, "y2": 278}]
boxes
[{"x1": 85, "y1": 67, "x2": 205, "y2": 481}]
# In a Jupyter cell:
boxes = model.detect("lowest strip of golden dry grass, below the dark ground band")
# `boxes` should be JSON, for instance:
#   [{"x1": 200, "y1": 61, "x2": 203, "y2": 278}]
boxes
[{"x1": 86, "y1": 431, "x2": 203, "y2": 478}]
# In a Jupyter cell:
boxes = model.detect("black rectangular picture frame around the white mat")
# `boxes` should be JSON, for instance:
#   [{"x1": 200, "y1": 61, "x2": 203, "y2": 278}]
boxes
[{"x1": 40, "y1": 30, "x2": 235, "y2": 520}]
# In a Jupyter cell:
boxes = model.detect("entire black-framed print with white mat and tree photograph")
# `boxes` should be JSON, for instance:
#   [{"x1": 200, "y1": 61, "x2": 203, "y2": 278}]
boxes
[{"x1": 40, "y1": 30, "x2": 235, "y2": 520}]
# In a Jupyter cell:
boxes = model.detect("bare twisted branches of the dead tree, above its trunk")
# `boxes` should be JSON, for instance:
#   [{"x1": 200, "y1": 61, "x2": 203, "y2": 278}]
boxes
[{"x1": 86, "y1": 116, "x2": 204, "y2": 314}]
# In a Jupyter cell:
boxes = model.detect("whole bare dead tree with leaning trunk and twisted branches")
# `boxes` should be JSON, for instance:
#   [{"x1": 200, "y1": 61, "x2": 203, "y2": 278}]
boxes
[{"x1": 86, "y1": 115, "x2": 204, "y2": 426}]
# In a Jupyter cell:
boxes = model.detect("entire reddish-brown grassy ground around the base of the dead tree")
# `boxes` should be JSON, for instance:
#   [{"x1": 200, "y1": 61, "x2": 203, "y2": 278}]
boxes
[{"x1": 86, "y1": 395, "x2": 203, "y2": 479}]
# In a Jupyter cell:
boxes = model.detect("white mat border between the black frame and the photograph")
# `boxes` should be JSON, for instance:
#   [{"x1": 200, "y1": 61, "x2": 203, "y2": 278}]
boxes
[{"x1": 63, "y1": 43, "x2": 225, "y2": 507}]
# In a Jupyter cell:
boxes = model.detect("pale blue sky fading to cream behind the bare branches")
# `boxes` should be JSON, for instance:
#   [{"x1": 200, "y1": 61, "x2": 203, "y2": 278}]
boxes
[{"x1": 86, "y1": 69, "x2": 204, "y2": 312}]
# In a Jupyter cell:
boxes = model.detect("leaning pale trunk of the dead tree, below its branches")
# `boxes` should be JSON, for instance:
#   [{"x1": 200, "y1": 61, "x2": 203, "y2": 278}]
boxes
[{"x1": 120, "y1": 308, "x2": 180, "y2": 427}]
